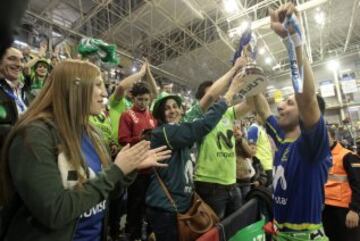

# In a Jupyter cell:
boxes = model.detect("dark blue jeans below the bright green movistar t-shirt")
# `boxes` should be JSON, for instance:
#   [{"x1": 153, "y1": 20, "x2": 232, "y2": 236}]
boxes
[{"x1": 195, "y1": 182, "x2": 242, "y2": 220}]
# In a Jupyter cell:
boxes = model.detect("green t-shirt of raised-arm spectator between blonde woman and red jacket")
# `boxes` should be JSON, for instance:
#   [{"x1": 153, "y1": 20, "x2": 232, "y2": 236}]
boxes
[{"x1": 109, "y1": 95, "x2": 132, "y2": 143}]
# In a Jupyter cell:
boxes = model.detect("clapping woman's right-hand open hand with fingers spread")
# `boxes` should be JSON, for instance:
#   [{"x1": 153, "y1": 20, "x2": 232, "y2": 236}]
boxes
[{"x1": 137, "y1": 146, "x2": 171, "y2": 169}]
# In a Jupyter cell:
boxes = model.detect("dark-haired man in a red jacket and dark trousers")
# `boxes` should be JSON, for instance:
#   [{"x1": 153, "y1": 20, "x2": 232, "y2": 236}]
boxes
[{"x1": 119, "y1": 82, "x2": 156, "y2": 241}]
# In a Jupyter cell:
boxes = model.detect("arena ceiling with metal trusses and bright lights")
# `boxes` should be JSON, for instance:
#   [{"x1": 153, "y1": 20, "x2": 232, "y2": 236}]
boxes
[{"x1": 24, "y1": 0, "x2": 360, "y2": 88}]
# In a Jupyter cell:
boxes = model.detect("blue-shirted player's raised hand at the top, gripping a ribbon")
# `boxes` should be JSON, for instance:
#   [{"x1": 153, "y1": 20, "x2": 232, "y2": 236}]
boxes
[{"x1": 269, "y1": 3, "x2": 299, "y2": 38}]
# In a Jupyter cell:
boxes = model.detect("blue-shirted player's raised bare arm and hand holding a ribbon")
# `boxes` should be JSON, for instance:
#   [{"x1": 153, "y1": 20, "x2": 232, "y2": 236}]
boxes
[{"x1": 270, "y1": 3, "x2": 320, "y2": 128}]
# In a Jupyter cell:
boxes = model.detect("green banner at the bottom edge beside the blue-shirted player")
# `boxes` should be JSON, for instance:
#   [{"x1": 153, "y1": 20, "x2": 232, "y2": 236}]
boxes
[{"x1": 229, "y1": 219, "x2": 265, "y2": 241}]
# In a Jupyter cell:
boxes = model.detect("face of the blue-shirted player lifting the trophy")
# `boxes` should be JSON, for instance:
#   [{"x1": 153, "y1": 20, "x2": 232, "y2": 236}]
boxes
[{"x1": 277, "y1": 95, "x2": 299, "y2": 130}]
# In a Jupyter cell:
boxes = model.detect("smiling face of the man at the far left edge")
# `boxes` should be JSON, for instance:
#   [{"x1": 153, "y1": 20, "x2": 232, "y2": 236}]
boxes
[{"x1": 0, "y1": 48, "x2": 23, "y2": 81}]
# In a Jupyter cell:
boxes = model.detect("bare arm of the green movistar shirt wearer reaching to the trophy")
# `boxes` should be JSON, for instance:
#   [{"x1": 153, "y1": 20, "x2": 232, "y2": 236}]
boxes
[{"x1": 200, "y1": 57, "x2": 246, "y2": 112}]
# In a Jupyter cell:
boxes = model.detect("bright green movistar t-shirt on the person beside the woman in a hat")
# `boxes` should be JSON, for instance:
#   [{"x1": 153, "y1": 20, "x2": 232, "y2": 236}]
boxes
[{"x1": 195, "y1": 107, "x2": 236, "y2": 185}]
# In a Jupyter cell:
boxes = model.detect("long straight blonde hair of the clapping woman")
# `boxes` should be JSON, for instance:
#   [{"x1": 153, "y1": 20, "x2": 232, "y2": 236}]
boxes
[{"x1": 0, "y1": 60, "x2": 110, "y2": 201}]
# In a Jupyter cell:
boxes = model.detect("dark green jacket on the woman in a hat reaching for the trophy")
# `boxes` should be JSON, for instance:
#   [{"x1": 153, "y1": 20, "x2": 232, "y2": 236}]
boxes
[{"x1": 146, "y1": 101, "x2": 228, "y2": 212}]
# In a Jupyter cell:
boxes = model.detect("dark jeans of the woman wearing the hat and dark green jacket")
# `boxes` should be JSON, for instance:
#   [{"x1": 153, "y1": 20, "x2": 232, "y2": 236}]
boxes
[{"x1": 146, "y1": 207, "x2": 178, "y2": 241}]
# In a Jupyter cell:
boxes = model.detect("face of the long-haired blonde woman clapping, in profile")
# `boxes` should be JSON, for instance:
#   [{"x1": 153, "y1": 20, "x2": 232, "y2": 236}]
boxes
[{"x1": 90, "y1": 77, "x2": 107, "y2": 115}]
